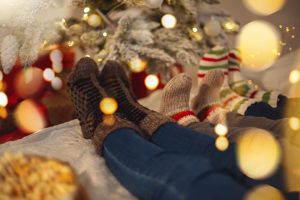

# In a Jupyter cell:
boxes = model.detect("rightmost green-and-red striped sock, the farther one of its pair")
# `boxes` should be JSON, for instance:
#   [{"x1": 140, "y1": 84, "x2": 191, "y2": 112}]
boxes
[{"x1": 228, "y1": 49, "x2": 279, "y2": 107}]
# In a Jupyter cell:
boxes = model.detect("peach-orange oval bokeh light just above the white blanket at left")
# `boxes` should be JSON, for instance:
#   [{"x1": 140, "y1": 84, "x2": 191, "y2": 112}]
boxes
[{"x1": 14, "y1": 99, "x2": 47, "y2": 133}]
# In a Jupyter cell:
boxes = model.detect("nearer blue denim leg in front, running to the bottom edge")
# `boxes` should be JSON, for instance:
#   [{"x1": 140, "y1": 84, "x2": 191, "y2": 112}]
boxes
[{"x1": 104, "y1": 129, "x2": 246, "y2": 200}]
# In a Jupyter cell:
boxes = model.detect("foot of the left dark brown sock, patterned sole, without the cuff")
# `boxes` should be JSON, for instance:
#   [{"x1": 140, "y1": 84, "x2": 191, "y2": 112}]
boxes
[{"x1": 68, "y1": 58, "x2": 107, "y2": 139}]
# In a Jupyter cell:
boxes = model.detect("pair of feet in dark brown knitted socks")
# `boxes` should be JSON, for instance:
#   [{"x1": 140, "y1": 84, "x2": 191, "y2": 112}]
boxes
[{"x1": 68, "y1": 58, "x2": 170, "y2": 155}]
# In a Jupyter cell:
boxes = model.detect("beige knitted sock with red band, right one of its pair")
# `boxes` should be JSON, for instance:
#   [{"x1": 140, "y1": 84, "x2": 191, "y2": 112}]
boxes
[{"x1": 192, "y1": 70, "x2": 226, "y2": 124}]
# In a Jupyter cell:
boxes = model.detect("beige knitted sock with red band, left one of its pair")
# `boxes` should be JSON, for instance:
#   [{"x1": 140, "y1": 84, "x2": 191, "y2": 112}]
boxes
[{"x1": 159, "y1": 74, "x2": 199, "y2": 126}]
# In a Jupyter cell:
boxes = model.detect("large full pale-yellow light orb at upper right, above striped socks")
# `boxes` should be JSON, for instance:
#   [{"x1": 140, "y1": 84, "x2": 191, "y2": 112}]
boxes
[{"x1": 237, "y1": 20, "x2": 281, "y2": 71}]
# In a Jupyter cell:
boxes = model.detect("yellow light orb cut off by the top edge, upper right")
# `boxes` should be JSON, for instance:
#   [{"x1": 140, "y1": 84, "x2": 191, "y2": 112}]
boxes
[{"x1": 243, "y1": 0, "x2": 285, "y2": 15}]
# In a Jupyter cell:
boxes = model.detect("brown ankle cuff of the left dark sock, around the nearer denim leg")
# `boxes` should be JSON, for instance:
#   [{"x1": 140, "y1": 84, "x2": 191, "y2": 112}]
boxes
[{"x1": 92, "y1": 115, "x2": 145, "y2": 156}]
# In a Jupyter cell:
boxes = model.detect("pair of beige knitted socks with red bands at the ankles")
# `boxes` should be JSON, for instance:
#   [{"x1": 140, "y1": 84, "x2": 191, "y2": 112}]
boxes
[{"x1": 159, "y1": 70, "x2": 227, "y2": 126}]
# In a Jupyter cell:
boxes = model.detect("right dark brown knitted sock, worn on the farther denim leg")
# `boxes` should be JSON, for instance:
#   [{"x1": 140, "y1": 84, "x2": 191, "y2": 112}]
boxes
[{"x1": 100, "y1": 61, "x2": 171, "y2": 135}]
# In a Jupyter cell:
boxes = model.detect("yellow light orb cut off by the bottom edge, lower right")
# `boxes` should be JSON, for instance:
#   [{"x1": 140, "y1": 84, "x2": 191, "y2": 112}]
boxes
[{"x1": 245, "y1": 185, "x2": 284, "y2": 200}]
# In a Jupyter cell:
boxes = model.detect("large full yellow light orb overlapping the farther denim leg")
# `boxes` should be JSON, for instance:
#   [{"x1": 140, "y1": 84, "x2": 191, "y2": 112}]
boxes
[{"x1": 237, "y1": 129, "x2": 281, "y2": 180}]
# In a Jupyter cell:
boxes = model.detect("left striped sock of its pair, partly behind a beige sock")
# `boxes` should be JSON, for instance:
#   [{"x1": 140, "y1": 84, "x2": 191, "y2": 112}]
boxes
[{"x1": 198, "y1": 46, "x2": 257, "y2": 115}]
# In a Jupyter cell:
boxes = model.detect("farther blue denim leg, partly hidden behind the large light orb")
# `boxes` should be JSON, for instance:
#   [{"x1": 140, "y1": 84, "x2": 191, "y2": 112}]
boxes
[{"x1": 150, "y1": 123, "x2": 284, "y2": 190}]
